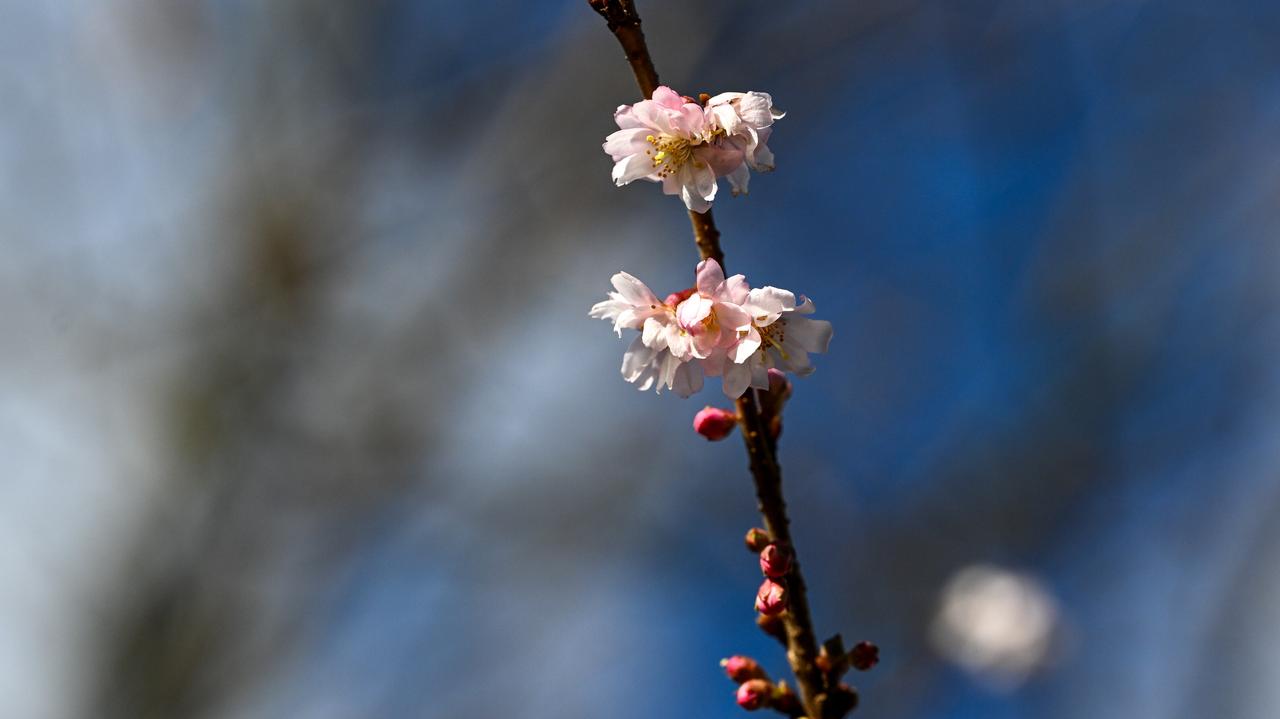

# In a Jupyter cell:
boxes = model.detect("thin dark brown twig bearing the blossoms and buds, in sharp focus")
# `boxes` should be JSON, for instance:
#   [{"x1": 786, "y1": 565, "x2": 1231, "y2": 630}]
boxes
[{"x1": 588, "y1": 0, "x2": 828, "y2": 719}]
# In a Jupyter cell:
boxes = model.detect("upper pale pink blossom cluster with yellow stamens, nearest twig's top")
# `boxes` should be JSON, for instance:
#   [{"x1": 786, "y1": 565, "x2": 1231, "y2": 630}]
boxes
[{"x1": 604, "y1": 86, "x2": 783, "y2": 212}]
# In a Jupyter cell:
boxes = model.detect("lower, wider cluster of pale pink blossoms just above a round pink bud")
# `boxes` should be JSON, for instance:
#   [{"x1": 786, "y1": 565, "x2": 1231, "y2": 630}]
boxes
[{"x1": 590, "y1": 260, "x2": 832, "y2": 399}]
